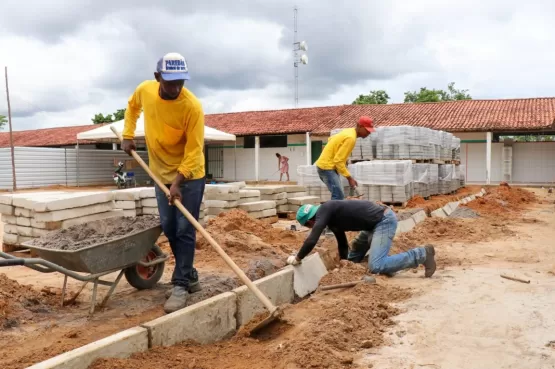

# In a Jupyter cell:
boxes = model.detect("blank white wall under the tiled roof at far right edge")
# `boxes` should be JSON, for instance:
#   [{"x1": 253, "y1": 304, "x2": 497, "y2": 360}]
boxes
[{"x1": 511, "y1": 142, "x2": 555, "y2": 183}]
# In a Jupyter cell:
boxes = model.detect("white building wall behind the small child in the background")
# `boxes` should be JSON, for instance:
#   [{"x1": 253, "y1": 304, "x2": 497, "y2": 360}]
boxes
[{"x1": 224, "y1": 134, "x2": 306, "y2": 181}]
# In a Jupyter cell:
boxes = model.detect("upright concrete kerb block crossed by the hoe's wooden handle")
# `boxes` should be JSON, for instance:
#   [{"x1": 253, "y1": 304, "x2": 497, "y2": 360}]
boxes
[{"x1": 233, "y1": 268, "x2": 295, "y2": 327}]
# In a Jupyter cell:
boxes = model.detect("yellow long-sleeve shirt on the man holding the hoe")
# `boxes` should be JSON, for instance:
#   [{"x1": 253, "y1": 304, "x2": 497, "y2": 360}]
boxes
[{"x1": 123, "y1": 80, "x2": 204, "y2": 184}]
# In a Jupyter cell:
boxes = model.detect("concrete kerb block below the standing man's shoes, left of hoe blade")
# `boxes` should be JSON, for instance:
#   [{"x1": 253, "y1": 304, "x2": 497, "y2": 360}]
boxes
[{"x1": 141, "y1": 292, "x2": 237, "y2": 346}]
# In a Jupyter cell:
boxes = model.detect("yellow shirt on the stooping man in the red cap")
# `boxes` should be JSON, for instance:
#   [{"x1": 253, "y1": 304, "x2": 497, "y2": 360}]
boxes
[{"x1": 314, "y1": 128, "x2": 357, "y2": 177}]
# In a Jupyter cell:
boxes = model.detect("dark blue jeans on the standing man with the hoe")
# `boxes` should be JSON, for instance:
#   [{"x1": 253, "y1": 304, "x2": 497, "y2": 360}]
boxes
[{"x1": 156, "y1": 178, "x2": 206, "y2": 288}]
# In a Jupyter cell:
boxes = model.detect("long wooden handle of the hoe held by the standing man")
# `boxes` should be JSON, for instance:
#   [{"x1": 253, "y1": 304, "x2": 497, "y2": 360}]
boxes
[{"x1": 110, "y1": 126, "x2": 277, "y2": 313}]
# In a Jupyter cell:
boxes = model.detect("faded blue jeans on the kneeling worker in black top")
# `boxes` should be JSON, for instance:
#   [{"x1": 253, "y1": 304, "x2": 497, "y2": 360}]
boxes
[{"x1": 347, "y1": 209, "x2": 426, "y2": 274}]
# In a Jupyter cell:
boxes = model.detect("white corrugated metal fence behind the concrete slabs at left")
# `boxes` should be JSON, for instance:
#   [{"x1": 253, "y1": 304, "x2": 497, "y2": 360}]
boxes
[{"x1": 0, "y1": 147, "x2": 149, "y2": 190}]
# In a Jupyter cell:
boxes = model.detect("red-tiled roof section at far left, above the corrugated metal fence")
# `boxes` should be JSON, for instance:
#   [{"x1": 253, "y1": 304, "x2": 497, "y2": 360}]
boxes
[{"x1": 0, "y1": 124, "x2": 101, "y2": 147}]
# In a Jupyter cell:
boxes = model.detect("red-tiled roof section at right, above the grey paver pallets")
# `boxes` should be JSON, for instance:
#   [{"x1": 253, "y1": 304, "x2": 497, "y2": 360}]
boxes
[{"x1": 312, "y1": 98, "x2": 555, "y2": 134}]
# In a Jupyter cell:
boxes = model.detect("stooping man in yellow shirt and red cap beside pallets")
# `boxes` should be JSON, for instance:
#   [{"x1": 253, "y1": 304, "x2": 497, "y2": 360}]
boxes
[{"x1": 314, "y1": 116, "x2": 375, "y2": 200}]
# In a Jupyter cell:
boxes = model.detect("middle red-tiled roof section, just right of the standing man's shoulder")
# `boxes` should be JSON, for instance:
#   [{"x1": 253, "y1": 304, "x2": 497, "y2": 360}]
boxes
[{"x1": 205, "y1": 105, "x2": 345, "y2": 136}]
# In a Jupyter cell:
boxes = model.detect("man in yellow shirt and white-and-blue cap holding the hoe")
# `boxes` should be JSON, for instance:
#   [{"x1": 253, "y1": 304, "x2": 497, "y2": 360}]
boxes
[{"x1": 122, "y1": 53, "x2": 205, "y2": 313}]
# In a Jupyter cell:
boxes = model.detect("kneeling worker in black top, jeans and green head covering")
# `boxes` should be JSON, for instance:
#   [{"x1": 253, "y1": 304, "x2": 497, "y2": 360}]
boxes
[{"x1": 287, "y1": 200, "x2": 436, "y2": 277}]
